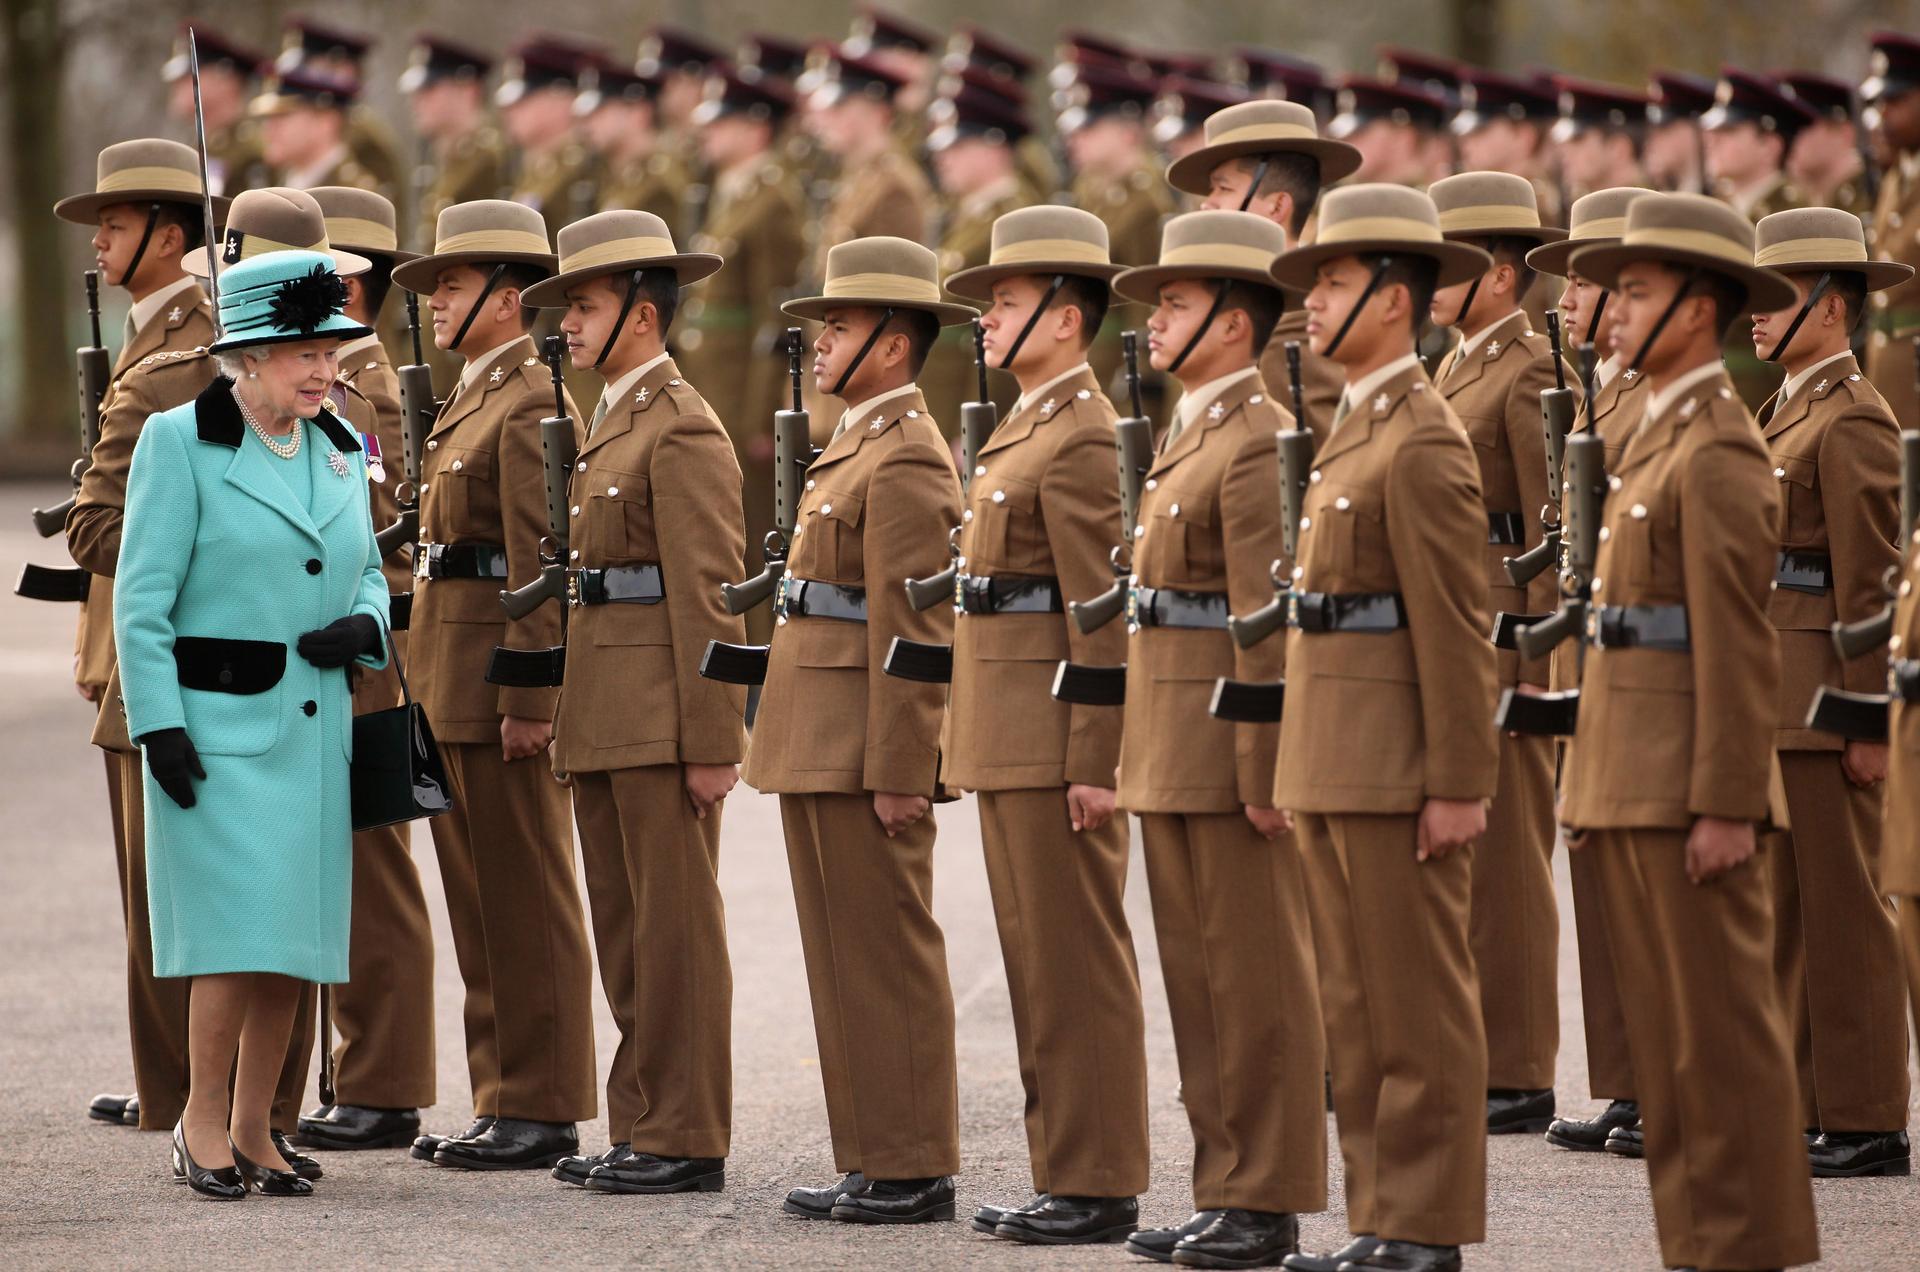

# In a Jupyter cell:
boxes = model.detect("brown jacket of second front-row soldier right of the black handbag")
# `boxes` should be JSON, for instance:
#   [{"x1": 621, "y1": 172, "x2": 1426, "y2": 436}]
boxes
[{"x1": 553, "y1": 357, "x2": 747, "y2": 772}]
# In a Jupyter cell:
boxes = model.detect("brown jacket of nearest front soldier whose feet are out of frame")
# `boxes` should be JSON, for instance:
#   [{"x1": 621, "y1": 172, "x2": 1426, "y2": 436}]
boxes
[{"x1": 1561, "y1": 375, "x2": 1784, "y2": 830}]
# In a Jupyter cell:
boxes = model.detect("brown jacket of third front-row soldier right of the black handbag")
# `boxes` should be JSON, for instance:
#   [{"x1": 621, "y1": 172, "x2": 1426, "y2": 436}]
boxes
[{"x1": 743, "y1": 390, "x2": 960, "y2": 797}]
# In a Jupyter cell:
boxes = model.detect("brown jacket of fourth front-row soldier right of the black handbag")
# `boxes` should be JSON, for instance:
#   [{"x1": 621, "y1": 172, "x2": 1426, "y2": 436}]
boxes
[{"x1": 941, "y1": 371, "x2": 1127, "y2": 790}]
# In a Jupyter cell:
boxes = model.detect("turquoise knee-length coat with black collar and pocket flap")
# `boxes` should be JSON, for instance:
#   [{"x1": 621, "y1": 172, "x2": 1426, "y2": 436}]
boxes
[{"x1": 113, "y1": 379, "x2": 388, "y2": 982}]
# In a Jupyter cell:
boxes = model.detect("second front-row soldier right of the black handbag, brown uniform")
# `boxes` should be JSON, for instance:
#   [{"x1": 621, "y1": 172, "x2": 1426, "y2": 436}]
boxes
[{"x1": 526, "y1": 211, "x2": 747, "y2": 1193}]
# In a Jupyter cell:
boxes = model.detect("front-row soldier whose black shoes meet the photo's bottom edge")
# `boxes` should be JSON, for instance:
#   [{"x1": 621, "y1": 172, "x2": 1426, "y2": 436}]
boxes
[{"x1": 1273, "y1": 184, "x2": 1500, "y2": 1272}]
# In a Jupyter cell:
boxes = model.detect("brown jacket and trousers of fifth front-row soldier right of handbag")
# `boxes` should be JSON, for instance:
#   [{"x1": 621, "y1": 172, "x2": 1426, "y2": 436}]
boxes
[{"x1": 1117, "y1": 369, "x2": 1327, "y2": 1212}]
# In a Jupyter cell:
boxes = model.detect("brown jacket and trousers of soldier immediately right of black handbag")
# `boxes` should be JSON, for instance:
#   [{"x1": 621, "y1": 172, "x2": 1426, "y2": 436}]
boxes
[{"x1": 409, "y1": 340, "x2": 595, "y2": 1122}]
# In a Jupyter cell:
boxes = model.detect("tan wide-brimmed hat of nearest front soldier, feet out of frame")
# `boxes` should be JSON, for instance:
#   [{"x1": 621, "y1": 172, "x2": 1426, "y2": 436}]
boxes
[{"x1": 1569, "y1": 194, "x2": 1799, "y2": 313}]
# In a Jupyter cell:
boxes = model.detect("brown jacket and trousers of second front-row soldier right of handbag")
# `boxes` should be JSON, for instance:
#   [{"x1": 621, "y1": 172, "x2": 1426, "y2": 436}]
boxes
[{"x1": 553, "y1": 359, "x2": 747, "y2": 1157}]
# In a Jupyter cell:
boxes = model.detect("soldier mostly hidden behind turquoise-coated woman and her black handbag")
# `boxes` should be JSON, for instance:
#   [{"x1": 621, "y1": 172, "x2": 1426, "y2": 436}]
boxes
[{"x1": 296, "y1": 186, "x2": 434, "y2": 1149}]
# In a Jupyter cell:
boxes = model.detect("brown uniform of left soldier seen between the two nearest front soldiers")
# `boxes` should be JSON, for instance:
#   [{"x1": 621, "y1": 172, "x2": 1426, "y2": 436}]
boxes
[{"x1": 1434, "y1": 313, "x2": 1559, "y2": 1091}]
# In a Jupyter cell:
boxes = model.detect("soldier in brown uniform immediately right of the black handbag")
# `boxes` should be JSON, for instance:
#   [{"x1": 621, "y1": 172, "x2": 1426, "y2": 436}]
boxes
[{"x1": 394, "y1": 201, "x2": 595, "y2": 1170}]
